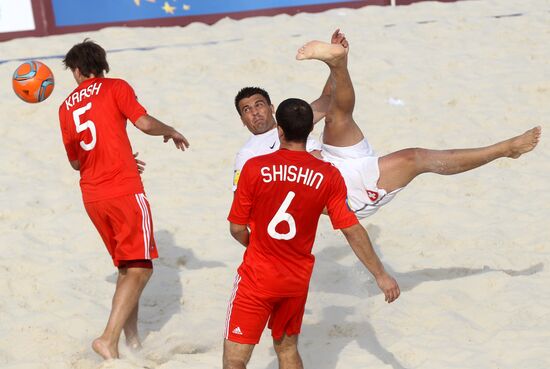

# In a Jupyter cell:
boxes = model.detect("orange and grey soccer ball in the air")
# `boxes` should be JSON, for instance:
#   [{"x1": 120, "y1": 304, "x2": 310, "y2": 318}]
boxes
[{"x1": 12, "y1": 60, "x2": 54, "y2": 103}]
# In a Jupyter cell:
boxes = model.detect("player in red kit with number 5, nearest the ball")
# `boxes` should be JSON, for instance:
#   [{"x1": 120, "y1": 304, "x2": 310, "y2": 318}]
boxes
[{"x1": 59, "y1": 40, "x2": 189, "y2": 359}]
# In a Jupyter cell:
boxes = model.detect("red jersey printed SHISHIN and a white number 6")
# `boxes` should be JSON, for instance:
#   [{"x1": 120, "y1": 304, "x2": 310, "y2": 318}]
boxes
[{"x1": 228, "y1": 150, "x2": 358, "y2": 296}]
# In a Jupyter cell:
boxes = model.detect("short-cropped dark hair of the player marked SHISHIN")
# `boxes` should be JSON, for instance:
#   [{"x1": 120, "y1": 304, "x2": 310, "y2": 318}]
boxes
[{"x1": 275, "y1": 98, "x2": 313, "y2": 142}]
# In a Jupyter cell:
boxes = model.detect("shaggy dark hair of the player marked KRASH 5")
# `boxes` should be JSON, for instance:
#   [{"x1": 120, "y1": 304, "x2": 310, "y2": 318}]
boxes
[{"x1": 63, "y1": 38, "x2": 109, "y2": 77}]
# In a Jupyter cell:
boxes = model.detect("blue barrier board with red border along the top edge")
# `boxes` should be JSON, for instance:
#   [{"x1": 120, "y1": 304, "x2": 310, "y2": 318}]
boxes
[{"x1": 0, "y1": 0, "x2": 459, "y2": 41}]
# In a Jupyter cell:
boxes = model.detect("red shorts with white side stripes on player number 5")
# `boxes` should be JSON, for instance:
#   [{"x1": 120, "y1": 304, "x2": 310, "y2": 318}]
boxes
[{"x1": 84, "y1": 193, "x2": 158, "y2": 267}]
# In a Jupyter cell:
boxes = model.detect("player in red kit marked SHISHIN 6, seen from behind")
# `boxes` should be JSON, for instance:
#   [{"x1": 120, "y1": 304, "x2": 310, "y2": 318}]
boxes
[{"x1": 223, "y1": 99, "x2": 400, "y2": 369}]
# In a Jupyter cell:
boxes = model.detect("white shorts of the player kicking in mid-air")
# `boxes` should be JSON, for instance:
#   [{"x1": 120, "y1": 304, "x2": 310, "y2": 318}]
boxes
[{"x1": 322, "y1": 139, "x2": 402, "y2": 219}]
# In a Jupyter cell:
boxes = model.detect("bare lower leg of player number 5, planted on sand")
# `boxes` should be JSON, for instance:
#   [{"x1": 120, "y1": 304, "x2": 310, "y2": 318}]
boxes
[{"x1": 92, "y1": 268, "x2": 153, "y2": 359}]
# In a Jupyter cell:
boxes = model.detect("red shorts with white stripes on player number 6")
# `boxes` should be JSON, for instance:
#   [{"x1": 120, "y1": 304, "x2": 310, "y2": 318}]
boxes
[{"x1": 224, "y1": 274, "x2": 307, "y2": 345}]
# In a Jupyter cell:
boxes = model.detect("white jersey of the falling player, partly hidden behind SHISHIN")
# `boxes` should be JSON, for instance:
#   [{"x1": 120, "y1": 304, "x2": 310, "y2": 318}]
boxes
[{"x1": 233, "y1": 127, "x2": 321, "y2": 191}]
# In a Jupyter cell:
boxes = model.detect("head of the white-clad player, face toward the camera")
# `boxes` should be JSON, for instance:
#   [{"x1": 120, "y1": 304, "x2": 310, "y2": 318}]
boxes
[{"x1": 235, "y1": 87, "x2": 277, "y2": 135}]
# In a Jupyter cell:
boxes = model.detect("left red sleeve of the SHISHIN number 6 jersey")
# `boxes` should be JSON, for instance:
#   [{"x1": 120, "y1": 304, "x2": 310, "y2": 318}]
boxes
[{"x1": 227, "y1": 161, "x2": 259, "y2": 225}]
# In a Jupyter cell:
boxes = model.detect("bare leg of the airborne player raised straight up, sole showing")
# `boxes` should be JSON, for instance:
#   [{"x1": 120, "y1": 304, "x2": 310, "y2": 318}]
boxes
[{"x1": 296, "y1": 36, "x2": 364, "y2": 146}]
